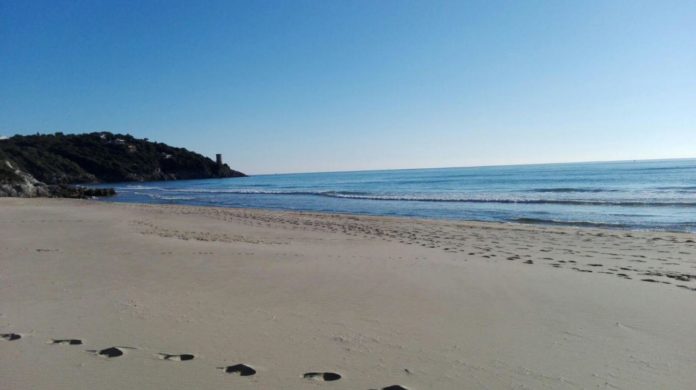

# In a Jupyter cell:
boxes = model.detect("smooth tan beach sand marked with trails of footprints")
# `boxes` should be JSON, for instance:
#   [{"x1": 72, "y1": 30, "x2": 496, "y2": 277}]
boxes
[{"x1": 0, "y1": 199, "x2": 696, "y2": 390}]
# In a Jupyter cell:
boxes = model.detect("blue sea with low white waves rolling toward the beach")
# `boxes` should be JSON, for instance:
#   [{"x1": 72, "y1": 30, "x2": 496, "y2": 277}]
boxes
[{"x1": 95, "y1": 159, "x2": 696, "y2": 232}]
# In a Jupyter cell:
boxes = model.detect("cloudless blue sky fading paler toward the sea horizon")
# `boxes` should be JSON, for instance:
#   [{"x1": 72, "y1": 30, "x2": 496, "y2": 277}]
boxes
[{"x1": 0, "y1": 0, "x2": 696, "y2": 173}]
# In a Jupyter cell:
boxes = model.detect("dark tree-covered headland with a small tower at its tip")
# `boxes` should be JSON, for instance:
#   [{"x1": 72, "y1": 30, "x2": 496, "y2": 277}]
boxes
[{"x1": 0, "y1": 132, "x2": 245, "y2": 196}]
